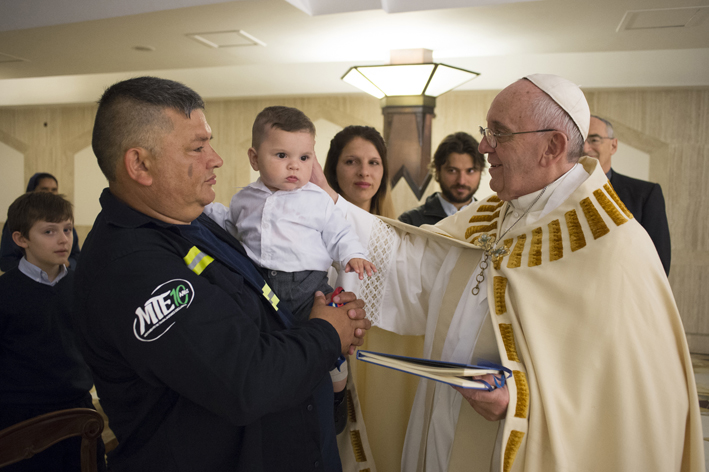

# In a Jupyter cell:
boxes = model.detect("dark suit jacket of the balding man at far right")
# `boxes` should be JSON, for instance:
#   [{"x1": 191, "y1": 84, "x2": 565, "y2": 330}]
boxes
[{"x1": 610, "y1": 168, "x2": 672, "y2": 275}]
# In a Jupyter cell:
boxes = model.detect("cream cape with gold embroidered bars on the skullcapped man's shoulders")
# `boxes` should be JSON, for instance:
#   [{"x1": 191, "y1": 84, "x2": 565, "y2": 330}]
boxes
[{"x1": 346, "y1": 158, "x2": 704, "y2": 472}]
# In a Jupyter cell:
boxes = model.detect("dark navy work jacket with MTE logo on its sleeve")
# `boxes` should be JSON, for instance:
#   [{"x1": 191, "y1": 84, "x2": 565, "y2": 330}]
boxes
[{"x1": 76, "y1": 189, "x2": 340, "y2": 472}]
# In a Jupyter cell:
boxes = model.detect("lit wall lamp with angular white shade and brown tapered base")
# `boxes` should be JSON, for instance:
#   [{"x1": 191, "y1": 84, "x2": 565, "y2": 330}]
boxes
[{"x1": 342, "y1": 49, "x2": 480, "y2": 200}]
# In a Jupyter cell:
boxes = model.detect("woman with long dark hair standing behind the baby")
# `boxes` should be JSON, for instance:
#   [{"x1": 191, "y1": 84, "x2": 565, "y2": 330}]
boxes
[{"x1": 323, "y1": 126, "x2": 423, "y2": 471}]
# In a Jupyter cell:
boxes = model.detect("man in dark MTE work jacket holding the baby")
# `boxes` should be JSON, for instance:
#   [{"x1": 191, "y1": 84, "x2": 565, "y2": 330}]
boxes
[{"x1": 76, "y1": 77, "x2": 369, "y2": 472}]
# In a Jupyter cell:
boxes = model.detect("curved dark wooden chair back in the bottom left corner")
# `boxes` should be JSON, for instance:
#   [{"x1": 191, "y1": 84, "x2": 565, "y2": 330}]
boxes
[{"x1": 0, "y1": 408, "x2": 103, "y2": 472}]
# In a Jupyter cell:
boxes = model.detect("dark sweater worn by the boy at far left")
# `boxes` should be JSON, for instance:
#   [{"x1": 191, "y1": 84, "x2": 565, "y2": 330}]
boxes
[{"x1": 0, "y1": 269, "x2": 93, "y2": 405}]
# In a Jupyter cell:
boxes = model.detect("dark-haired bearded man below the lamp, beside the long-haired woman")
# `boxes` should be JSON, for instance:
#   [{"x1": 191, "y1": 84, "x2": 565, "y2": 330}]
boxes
[{"x1": 399, "y1": 131, "x2": 485, "y2": 226}]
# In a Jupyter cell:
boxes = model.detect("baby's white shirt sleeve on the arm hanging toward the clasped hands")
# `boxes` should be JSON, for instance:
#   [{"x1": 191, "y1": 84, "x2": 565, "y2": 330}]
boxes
[{"x1": 322, "y1": 194, "x2": 367, "y2": 268}]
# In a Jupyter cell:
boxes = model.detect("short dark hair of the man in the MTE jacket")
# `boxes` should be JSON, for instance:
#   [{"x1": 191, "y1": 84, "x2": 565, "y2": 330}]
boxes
[{"x1": 91, "y1": 77, "x2": 204, "y2": 182}]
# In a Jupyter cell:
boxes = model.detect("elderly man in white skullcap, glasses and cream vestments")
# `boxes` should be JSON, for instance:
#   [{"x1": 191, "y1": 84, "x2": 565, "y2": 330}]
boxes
[{"x1": 328, "y1": 75, "x2": 704, "y2": 472}]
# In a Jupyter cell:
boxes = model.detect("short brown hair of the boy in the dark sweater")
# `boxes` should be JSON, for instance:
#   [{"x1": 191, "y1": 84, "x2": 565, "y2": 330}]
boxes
[{"x1": 6, "y1": 192, "x2": 74, "y2": 238}]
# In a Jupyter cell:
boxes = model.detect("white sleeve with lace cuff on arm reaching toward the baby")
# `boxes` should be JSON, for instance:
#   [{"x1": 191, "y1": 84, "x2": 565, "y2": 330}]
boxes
[{"x1": 336, "y1": 198, "x2": 451, "y2": 335}]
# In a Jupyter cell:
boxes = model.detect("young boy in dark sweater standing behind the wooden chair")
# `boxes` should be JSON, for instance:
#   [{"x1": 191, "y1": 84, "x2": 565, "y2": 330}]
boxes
[{"x1": 0, "y1": 192, "x2": 106, "y2": 472}]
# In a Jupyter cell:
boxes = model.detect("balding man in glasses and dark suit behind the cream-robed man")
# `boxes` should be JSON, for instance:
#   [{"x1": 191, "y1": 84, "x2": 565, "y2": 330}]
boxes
[{"x1": 584, "y1": 115, "x2": 672, "y2": 275}]
